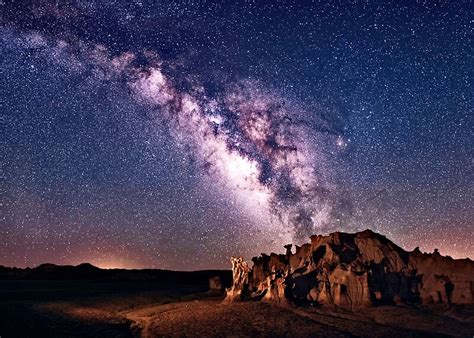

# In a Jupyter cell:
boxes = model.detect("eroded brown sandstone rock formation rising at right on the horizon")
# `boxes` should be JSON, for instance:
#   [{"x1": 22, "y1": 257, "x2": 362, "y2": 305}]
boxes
[{"x1": 227, "y1": 230, "x2": 474, "y2": 308}]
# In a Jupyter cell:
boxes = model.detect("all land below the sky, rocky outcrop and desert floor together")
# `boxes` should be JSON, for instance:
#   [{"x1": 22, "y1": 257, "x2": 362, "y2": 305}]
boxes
[{"x1": 0, "y1": 231, "x2": 474, "y2": 338}]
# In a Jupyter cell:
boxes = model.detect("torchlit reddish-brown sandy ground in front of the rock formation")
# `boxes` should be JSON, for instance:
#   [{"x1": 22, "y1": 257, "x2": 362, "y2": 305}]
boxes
[{"x1": 122, "y1": 300, "x2": 474, "y2": 337}]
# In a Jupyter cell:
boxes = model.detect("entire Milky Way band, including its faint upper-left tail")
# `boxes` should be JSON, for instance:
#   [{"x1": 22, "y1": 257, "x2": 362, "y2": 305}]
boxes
[{"x1": 7, "y1": 29, "x2": 342, "y2": 242}]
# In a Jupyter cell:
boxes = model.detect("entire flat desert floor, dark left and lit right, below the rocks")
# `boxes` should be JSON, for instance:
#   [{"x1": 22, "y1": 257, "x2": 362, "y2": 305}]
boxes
[{"x1": 0, "y1": 280, "x2": 474, "y2": 338}]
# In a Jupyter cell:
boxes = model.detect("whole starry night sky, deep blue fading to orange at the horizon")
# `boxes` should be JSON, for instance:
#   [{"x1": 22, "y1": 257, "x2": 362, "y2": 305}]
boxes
[{"x1": 0, "y1": 0, "x2": 474, "y2": 270}]
